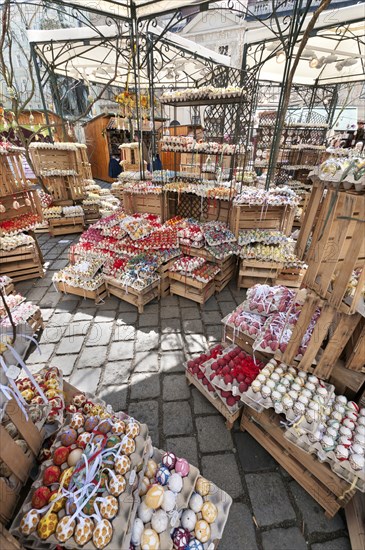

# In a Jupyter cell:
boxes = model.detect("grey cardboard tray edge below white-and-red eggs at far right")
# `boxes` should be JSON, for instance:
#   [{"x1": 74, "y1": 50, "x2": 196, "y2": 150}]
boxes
[{"x1": 284, "y1": 430, "x2": 365, "y2": 493}]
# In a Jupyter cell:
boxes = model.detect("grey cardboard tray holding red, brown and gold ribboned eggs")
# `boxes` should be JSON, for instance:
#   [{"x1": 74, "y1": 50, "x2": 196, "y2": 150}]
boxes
[{"x1": 10, "y1": 424, "x2": 151, "y2": 550}]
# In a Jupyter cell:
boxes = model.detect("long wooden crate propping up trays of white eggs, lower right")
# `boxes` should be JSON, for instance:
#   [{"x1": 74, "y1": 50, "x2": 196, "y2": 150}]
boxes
[{"x1": 241, "y1": 407, "x2": 356, "y2": 518}]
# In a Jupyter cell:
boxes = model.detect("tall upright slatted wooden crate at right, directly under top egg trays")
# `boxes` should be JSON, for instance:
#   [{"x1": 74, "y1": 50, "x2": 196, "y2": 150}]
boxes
[{"x1": 303, "y1": 189, "x2": 365, "y2": 313}]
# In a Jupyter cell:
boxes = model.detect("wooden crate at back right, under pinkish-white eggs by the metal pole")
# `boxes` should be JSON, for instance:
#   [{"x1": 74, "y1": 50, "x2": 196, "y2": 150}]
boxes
[{"x1": 231, "y1": 204, "x2": 296, "y2": 238}]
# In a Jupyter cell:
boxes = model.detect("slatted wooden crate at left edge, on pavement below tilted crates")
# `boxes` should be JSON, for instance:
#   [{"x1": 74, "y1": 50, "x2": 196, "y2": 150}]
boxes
[{"x1": 0, "y1": 244, "x2": 44, "y2": 282}]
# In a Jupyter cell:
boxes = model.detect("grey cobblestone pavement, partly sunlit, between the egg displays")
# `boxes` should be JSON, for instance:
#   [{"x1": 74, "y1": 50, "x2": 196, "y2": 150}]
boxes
[{"x1": 16, "y1": 234, "x2": 350, "y2": 550}]
